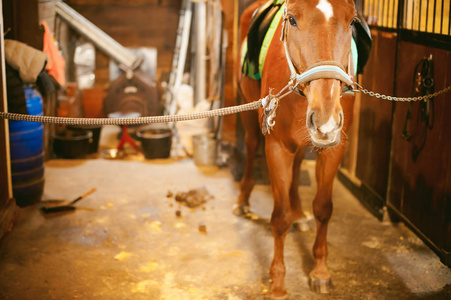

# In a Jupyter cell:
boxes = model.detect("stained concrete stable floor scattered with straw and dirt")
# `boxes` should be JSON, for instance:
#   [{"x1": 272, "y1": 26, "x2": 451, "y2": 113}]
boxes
[{"x1": 0, "y1": 125, "x2": 451, "y2": 300}]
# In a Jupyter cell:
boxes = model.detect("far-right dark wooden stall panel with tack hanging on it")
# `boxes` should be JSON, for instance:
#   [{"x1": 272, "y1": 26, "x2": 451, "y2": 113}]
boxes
[{"x1": 387, "y1": 42, "x2": 451, "y2": 265}]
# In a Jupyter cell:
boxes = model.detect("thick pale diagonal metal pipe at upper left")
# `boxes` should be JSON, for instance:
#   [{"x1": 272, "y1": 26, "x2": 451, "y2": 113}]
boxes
[{"x1": 55, "y1": 2, "x2": 138, "y2": 71}]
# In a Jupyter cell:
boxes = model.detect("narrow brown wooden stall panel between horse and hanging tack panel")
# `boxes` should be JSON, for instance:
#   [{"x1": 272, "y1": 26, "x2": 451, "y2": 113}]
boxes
[{"x1": 356, "y1": 31, "x2": 396, "y2": 199}]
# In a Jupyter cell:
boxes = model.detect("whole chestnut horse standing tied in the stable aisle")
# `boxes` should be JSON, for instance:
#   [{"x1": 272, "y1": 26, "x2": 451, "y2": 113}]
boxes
[{"x1": 235, "y1": 0, "x2": 358, "y2": 299}]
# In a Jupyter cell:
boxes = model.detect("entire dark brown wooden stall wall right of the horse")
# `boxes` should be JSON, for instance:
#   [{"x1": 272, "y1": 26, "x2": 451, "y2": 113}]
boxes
[{"x1": 339, "y1": 29, "x2": 451, "y2": 265}]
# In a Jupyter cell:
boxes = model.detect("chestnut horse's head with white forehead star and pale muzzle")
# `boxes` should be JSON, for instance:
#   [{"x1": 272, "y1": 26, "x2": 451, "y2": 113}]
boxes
[{"x1": 284, "y1": 0, "x2": 358, "y2": 147}]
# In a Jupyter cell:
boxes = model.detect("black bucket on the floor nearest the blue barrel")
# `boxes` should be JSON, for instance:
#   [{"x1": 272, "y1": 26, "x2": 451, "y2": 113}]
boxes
[{"x1": 53, "y1": 129, "x2": 92, "y2": 158}]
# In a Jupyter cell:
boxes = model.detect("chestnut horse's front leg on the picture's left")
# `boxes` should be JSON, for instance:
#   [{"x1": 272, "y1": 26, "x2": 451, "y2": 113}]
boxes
[{"x1": 265, "y1": 137, "x2": 295, "y2": 299}]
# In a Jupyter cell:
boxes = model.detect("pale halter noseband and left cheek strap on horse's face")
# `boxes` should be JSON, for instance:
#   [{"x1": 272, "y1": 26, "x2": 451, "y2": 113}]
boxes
[{"x1": 280, "y1": 1, "x2": 354, "y2": 86}]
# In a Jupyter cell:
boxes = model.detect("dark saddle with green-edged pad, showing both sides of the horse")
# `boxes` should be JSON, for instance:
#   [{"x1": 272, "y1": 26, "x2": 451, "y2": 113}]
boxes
[{"x1": 241, "y1": 0, "x2": 372, "y2": 79}]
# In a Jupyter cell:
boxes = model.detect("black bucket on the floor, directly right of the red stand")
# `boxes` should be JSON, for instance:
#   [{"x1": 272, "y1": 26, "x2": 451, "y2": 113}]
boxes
[{"x1": 136, "y1": 127, "x2": 172, "y2": 159}]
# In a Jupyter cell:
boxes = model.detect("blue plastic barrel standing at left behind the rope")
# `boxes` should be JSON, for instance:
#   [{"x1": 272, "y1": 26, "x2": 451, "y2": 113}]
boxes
[{"x1": 9, "y1": 87, "x2": 44, "y2": 207}]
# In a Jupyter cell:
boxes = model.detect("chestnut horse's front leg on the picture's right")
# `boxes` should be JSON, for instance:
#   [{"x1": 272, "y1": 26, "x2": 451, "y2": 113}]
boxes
[{"x1": 310, "y1": 143, "x2": 345, "y2": 293}]
